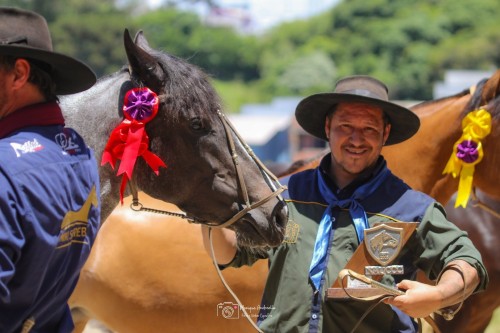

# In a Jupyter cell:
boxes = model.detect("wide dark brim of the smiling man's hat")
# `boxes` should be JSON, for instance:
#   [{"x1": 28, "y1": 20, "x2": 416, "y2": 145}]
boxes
[{"x1": 295, "y1": 93, "x2": 420, "y2": 146}]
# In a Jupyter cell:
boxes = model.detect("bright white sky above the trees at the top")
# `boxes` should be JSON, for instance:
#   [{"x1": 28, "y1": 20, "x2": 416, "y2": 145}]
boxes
[{"x1": 148, "y1": 0, "x2": 339, "y2": 31}]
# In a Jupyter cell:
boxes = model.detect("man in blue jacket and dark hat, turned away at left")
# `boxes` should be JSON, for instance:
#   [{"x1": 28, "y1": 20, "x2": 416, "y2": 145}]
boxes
[{"x1": 0, "y1": 7, "x2": 100, "y2": 333}]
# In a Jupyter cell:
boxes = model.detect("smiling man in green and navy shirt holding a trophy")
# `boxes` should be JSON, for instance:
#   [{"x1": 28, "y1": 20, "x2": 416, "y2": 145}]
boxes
[{"x1": 202, "y1": 76, "x2": 487, "y2": 333}]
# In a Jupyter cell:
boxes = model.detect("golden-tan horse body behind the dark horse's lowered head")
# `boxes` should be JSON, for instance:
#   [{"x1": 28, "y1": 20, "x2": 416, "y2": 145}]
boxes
[{"x1": 70, "y1": 193, "x2": 267, "y2": 333}]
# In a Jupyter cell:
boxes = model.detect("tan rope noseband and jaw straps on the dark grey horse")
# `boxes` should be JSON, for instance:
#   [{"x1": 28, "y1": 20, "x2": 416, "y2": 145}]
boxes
[{"x1": 129, "y1": 110, "x2": 287, "y2": 228}]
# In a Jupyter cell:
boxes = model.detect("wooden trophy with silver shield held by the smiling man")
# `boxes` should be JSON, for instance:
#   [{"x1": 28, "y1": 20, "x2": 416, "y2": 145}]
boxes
[{"x1": 325, "y1": 222, "x2": 418, "y2": 300}]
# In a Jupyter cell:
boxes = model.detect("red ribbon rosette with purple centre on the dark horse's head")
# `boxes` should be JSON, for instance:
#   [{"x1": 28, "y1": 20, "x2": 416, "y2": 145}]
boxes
[{"x1": 101, "y1": 88, "x2": 167, "y2": 204}]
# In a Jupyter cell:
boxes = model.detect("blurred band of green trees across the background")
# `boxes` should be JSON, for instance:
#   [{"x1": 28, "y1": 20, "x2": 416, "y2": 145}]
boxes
[{"x1": 0, "y1": 0, "x2": 500, "y2": 111}]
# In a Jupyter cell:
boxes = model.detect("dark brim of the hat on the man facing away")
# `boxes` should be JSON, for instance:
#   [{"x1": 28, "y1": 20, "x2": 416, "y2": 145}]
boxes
[{"x1": 0, "y1": 45, "x2": 97, "y2": 95}]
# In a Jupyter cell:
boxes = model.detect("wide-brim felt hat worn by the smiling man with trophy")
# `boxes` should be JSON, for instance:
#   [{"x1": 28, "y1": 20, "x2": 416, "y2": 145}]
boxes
[{"x1": 295, "y1": 75, "x2": 420, "y2": 146}]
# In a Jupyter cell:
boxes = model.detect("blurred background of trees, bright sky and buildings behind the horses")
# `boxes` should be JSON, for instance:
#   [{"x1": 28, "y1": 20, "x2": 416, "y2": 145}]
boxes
[{"x1": 0, "y1": 0, "x2": 500, "y2": 332}]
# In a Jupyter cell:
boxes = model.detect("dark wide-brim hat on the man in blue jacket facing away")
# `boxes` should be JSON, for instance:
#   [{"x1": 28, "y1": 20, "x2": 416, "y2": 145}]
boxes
[{"x1": 0, "y1": 7, "x2": 96, "y2": 95}]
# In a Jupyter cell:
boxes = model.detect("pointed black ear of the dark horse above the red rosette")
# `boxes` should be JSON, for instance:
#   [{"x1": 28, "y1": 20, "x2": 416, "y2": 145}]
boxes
[{"x1": 123, "y1": 29, "x2": 165, "y2": 89}]
